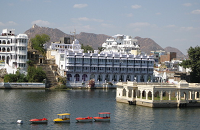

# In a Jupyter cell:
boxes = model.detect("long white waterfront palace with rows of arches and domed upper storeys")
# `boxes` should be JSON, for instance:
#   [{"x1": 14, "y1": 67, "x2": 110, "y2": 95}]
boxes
[{"x1": 51, "y1": 34, "x2": 154, "y2": 84}]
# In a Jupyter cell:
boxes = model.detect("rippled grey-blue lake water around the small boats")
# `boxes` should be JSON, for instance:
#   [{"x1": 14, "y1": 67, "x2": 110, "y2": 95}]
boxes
[{"x1": 0, "y1": 89, "x2": 200, "y2": 130}]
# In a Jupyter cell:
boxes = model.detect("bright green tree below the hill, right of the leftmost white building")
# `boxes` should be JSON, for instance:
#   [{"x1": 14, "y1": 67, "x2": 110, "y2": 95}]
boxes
[{"x1": 31, "y1": 34, "x2": 50, "y2": 56}]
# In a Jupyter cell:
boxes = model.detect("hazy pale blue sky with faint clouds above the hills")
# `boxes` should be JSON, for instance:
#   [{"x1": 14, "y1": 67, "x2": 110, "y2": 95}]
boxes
[{"x1": 0, "y1": 0, "x2": 200, "y2": 54}]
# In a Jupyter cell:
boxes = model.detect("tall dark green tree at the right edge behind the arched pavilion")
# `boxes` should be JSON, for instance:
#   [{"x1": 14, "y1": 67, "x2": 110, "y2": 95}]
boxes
[{"x1": 180, "y1": 46, "x2": 200, "y2": 83}]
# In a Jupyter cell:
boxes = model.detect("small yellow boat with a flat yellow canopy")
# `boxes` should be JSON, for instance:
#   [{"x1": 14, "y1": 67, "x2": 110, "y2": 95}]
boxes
[{"x1": 53, "y1": 113, "x2": 70, "y2": 123}]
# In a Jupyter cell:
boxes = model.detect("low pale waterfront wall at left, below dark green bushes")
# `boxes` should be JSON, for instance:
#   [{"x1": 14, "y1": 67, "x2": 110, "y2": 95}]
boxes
[{"x1": 0, "y1": 82, "x2": 45, "y2": 89}]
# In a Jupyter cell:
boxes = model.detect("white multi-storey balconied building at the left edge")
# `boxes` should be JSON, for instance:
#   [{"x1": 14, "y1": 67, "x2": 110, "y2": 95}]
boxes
[{"x1": 0, "y1": 29, "x2": 28, "y2": 73}]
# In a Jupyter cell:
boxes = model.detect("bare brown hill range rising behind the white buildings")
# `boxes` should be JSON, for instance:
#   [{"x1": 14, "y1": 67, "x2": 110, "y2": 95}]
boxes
[{"x1": 25, "y1": 25, "x2": 185, "y2": 57}]
